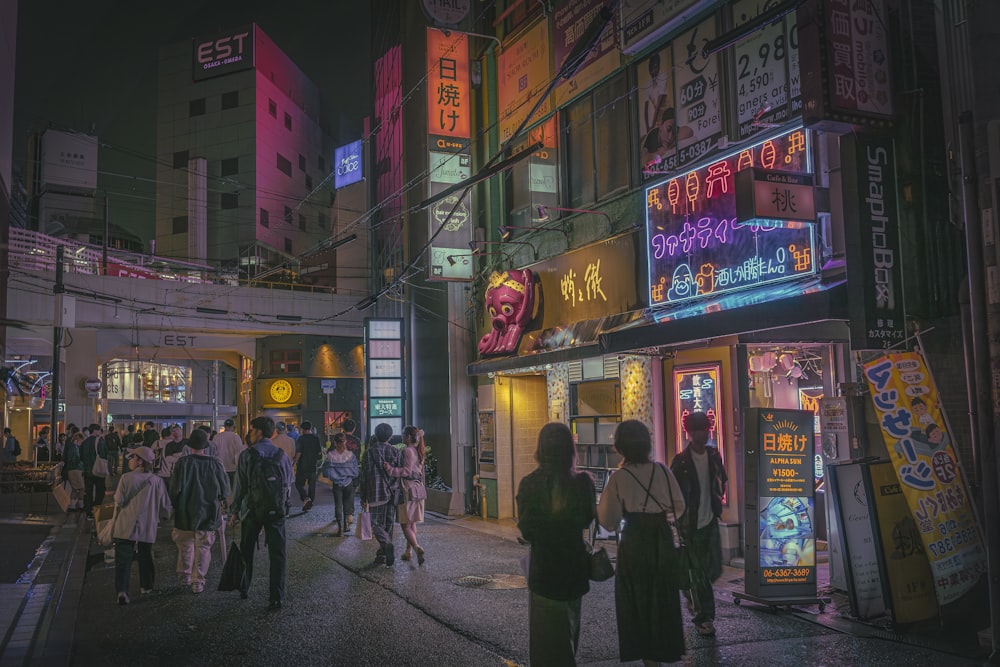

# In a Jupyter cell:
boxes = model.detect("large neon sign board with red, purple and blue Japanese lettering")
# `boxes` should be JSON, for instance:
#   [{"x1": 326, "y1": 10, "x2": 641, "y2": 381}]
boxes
[{"x1": 646, "y1": 129, "x2": 817, "y2": 307}]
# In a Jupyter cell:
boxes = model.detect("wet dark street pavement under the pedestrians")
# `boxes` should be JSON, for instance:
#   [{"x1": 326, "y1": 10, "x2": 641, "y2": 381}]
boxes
[{"x1": 0, "y1": 488, "x2": 986, "y2": 667}]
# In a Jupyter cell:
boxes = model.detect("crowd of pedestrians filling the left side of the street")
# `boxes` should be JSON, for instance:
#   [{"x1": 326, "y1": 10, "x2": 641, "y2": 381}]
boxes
[{"x1": 41, "y1": 416, "x2": 426, "y2": 609}]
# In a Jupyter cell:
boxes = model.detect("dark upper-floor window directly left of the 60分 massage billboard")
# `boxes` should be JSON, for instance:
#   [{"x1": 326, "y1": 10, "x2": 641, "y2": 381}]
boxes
[{"x1": 563, "y1": 73, "x2": 631, "y2": 208}]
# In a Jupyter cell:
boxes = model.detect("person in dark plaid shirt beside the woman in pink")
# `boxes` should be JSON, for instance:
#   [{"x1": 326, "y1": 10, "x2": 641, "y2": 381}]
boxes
[{"x1": 360, "y1": 423, "x2": 403, "y2": 567}]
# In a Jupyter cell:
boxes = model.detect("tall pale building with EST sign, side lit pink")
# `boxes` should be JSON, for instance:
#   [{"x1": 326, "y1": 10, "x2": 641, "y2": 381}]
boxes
[{"x1": 156, "y1": 25, "x2": 334, "y2": 276}]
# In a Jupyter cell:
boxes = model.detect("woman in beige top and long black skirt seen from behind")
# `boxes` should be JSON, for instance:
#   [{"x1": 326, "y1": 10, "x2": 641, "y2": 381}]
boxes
[{"x1": 597, "y1": 419, "x2": 684, "y2": 667}]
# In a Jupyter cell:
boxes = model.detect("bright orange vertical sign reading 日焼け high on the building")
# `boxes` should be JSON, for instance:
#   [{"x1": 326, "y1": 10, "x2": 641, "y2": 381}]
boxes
[{"x1": 427, "y1": 28, "x2": 471, "y2": 139}]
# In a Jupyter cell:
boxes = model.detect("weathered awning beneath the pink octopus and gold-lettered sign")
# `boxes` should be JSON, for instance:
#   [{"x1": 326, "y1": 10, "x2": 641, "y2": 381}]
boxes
[{"x1": 466, "y1": 310, "x2": 646, "y2": 375}]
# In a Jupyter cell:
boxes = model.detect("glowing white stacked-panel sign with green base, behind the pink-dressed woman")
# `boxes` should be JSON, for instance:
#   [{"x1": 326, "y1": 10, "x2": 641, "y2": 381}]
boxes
[{"x1": 365, "y1": 318, "x2": 406, "y2": 434}]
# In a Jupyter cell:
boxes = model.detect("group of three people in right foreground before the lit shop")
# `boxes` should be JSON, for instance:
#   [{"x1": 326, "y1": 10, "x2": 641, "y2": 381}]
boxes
[{"x1": 517, "y1": 412, "x2": 728, "y2": 666}]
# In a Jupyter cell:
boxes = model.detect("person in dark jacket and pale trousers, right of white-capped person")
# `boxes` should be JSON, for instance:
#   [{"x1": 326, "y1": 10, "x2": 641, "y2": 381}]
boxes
[{"x1": 168, "y1": 429, "x2": 229, "y2": 593}]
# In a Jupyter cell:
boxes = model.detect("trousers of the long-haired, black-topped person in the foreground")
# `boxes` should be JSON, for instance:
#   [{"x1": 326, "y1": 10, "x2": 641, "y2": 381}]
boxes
[{"x1": 528, "y1": 593, "x2": 583, "y2": 665}]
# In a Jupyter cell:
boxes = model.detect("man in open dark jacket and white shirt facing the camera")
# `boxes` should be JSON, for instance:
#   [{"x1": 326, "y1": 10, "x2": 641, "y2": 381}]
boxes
[{"x1": 670, "y1": 412, "x2": 729, "y2": 637}]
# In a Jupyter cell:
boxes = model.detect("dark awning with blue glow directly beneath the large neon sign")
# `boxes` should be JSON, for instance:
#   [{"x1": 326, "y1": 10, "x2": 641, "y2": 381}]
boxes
[{"x1": 600, "y1": 278, "x2": 847, "y2": 354}]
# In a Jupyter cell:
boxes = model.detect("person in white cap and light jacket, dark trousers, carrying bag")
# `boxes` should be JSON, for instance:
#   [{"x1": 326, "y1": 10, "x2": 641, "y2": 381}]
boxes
[{"x1": 111, "y1": 447, "x2": 170, "y2": 605}]
